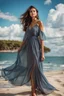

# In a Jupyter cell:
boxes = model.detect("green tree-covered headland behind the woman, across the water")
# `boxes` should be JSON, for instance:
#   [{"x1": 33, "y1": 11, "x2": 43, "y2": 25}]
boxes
[{"x1": 0, "y1": 40, "x2": 50, "y2": 52}]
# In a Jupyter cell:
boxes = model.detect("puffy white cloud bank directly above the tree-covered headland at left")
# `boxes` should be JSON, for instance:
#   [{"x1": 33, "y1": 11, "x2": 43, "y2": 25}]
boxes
[{"x1": 0, "y1": 24, "x2": 24, "y2": 40}]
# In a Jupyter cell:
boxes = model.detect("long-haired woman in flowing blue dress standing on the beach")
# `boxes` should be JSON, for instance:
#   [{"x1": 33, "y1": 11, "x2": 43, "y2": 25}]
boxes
[{"x1": 2, "y1": 6, "x2": 56, "y2": 96}]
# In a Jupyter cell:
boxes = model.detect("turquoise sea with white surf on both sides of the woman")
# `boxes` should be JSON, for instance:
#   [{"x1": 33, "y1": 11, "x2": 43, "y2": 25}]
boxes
[{"x1": 0, "y1": 52, "x2": 64, "y2": 72}]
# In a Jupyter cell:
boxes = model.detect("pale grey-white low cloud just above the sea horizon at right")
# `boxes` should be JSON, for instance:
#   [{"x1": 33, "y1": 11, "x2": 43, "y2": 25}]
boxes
[{"x1": 45, "y1": 37, "x2": 64, "y2": 56}]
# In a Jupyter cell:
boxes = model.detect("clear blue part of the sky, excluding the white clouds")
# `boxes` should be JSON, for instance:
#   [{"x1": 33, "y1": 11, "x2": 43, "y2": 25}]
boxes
[{"x1": 0, "y1": 0, "x2": 64, "y2": 26}]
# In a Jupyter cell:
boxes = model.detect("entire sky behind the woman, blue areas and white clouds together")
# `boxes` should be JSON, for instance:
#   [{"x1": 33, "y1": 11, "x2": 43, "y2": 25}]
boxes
[{"x1": 0, "y1": 0, "x2": 64, "y2": 56}]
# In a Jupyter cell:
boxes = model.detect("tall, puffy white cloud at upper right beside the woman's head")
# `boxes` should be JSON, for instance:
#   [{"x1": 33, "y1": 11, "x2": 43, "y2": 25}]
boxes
[{"x1": 45, "y1": 4, "x2": 64, "y2": 37}]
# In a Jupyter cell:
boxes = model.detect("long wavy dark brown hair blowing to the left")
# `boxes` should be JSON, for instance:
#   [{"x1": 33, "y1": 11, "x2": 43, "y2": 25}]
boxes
[{"x1": 20, "y1": 6, "x2": 39, "y2": 31}]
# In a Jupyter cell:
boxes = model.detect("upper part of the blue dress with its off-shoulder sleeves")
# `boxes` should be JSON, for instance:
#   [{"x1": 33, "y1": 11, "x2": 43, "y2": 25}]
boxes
[{"x1": 23, "y1": 24, "x2": 46, "y2": 40}]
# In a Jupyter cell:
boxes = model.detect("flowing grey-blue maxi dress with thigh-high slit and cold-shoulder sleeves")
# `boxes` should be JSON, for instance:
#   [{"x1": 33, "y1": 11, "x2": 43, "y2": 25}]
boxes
[{"x1": 1, "y1": 24, "x2": 56, "y2": 94}]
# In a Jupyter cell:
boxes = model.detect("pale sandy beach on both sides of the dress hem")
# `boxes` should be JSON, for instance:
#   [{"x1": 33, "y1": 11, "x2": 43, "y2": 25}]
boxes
[{"x1": 0, "y1": 71, "x2": 64, "y2": 96}]
